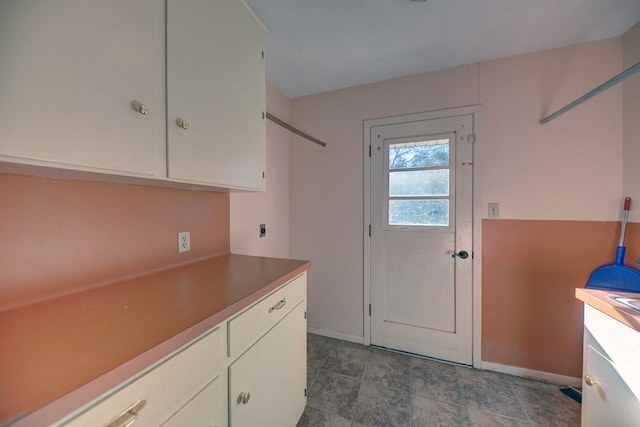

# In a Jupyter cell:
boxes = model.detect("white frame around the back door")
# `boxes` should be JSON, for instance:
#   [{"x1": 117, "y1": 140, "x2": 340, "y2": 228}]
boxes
[{"x1": 362, "y1": 105, "x2": 483, "y2": 368}]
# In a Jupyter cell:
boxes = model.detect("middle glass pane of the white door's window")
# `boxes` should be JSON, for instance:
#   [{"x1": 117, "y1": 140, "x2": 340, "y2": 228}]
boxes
[{"x1": 389, "y1": 169, "x2": 449, "y2": 197}]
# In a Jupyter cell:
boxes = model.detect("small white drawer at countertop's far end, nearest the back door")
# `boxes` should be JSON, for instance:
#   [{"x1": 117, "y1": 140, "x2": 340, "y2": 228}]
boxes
[{"x1": 227, "y1": 273, "x2": 307, "y2": 357}]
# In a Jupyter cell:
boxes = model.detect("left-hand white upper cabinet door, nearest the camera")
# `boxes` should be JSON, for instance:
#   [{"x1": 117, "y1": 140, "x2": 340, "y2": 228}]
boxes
[{"x1": 0, "y1": 0, "x2": 165, "y2": 176}]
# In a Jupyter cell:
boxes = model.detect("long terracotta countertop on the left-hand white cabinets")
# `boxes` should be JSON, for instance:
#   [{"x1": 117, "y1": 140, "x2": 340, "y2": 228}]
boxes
[{"x1": 0, "y1": 255, "x2": 309, "y2": 425}]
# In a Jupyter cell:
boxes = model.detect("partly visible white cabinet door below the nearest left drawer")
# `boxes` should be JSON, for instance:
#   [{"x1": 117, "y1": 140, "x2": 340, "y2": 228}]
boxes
[{"x1": 163, "y1": 376, "x2": 227, "y2": 427}]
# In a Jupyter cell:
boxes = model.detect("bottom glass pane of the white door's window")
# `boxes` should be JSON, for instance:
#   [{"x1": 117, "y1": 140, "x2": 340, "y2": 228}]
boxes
[{"x1": 389, "y1": 199, "x2": 449, "y2": 227}]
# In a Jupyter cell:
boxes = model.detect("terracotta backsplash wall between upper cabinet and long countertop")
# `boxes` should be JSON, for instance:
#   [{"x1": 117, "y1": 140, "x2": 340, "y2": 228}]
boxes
[{"x1": 0, "y1": 174, "x2": 229, "y2": 309}]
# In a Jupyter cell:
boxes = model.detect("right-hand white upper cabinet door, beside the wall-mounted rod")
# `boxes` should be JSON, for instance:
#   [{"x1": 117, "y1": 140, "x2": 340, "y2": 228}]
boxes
[{"x1": 167, "y1": 0, "x2": 266, "y2": 190}]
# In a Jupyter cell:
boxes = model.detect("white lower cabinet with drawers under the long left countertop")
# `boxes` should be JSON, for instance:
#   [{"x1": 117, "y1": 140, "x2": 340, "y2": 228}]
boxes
[{"x1": 54, "y1": 273, "x2": 307, "y2": 427}]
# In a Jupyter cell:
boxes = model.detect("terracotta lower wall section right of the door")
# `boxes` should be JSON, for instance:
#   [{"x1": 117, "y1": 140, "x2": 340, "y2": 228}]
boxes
[{"x1": 482, "y1": 219, "x2": 631, "y2": 377}]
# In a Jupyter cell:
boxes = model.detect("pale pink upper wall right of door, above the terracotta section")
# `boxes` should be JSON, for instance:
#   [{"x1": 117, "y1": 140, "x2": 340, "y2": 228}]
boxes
[{"x1": 480, "y1": 38, "x2": 622, "y2": 221}]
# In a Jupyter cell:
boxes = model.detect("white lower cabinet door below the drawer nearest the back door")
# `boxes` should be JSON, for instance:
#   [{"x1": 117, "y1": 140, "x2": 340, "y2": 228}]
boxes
[{"x1": 229, "y1": 301, "x2": 307, "y2": 427}]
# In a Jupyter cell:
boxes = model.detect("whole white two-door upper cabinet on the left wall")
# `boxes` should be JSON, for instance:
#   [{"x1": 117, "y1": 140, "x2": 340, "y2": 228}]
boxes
[{"x1": 0, "y1": 0, "x2": 266, "y2": 190}]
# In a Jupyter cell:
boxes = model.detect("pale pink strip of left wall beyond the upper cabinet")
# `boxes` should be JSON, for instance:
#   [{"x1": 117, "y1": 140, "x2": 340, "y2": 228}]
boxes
[{"x1": 230, "y1": 83, "x2": 289, "y2": 258}]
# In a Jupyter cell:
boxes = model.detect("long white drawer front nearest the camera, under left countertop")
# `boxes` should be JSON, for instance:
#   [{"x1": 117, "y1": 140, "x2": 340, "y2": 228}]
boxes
[{"x1": 57, "y1": 328, "x2": 223, "y2": 427}]
